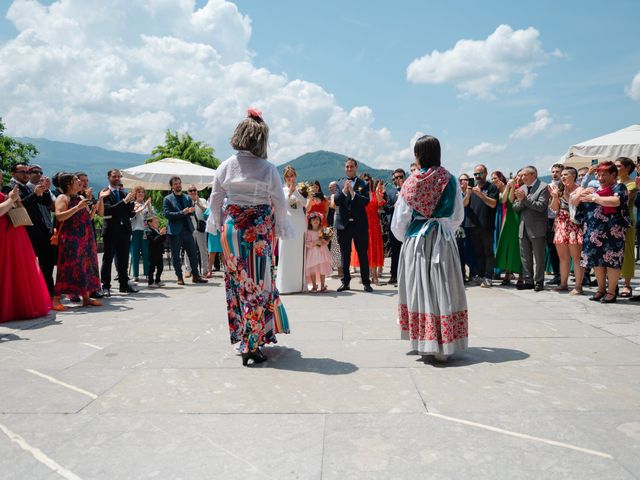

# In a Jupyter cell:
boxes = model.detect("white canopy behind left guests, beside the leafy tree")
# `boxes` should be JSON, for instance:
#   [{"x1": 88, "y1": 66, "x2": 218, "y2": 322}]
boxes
[{"x1": 122, "y1": 158, "x2": 216, "y2": 190}]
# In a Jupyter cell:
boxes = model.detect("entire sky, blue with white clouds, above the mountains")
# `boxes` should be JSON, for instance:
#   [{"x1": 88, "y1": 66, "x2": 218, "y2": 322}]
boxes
[{"x1": 0, "y1": 0, "x2": 640, "y2": 171}]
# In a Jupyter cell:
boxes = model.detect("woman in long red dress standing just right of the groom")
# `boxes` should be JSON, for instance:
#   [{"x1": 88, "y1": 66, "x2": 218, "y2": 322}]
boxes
[{"x1": 351, "y1": 173, "x2": 387, "y2": 285}]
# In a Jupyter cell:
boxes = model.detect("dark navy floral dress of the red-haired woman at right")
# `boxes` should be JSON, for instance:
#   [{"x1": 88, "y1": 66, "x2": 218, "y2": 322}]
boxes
[{"x1": 580, "y1": 183, "x2": 631, "y2": 268}]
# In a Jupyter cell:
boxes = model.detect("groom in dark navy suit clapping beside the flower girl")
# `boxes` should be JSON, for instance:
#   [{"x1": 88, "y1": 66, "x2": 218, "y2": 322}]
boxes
[{"x1": 333, "y1": 158, "x2": 373, "y2": 292}]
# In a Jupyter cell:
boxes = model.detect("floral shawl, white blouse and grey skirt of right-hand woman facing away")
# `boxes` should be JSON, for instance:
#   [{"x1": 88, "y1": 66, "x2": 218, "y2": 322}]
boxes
[{"x1": 391, "y1": 167, "x2": 469, "y2": 355}]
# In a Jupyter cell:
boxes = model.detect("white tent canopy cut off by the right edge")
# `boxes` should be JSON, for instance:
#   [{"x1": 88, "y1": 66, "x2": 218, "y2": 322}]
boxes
[{"x1": 561, "y1": 125, "x2": 640, "y2": 168}]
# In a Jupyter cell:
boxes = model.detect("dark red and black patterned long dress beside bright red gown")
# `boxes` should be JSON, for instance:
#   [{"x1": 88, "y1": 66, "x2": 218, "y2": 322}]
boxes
[{"x1": 55, "y1": 196, "x2": 100, "y2": 295}]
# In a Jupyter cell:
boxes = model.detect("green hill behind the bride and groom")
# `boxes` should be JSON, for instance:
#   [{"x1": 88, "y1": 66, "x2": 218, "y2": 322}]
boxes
[{"x1": 278, "y1": 150, "x2": 393, "y2": 194}]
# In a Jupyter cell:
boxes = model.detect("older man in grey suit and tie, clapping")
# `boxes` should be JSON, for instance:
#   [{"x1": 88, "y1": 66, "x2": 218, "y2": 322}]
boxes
[{"x1": 513, "y1": 166, "x2": 550, "y2": 292}]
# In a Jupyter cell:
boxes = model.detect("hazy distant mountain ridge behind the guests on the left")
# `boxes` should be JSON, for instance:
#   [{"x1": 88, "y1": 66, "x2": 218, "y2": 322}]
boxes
[{"x1": 18, "y1": 137, "x2": 149, "y2": 188}]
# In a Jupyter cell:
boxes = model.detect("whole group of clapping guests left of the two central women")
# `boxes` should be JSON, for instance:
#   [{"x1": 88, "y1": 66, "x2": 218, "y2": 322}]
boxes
[{"x1": 0, "y1": 164, "x2": 222, "y2": 322}]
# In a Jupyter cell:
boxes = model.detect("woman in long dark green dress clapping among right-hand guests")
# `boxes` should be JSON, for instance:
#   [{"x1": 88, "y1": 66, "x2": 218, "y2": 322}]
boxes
[{"x1": 495, "y1": 172, "x2": 522, "y2": 285}]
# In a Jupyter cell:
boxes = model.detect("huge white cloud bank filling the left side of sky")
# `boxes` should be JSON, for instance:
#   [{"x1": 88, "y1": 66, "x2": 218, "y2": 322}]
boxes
[{"x1": 0, "y1": 0, "x2": 402, "y2": 166}]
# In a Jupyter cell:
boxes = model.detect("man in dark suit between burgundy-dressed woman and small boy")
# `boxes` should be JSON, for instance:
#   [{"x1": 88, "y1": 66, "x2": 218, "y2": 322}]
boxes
[{"x1": 100, "y1": 169, "x2": 138, "y2": 296}]
